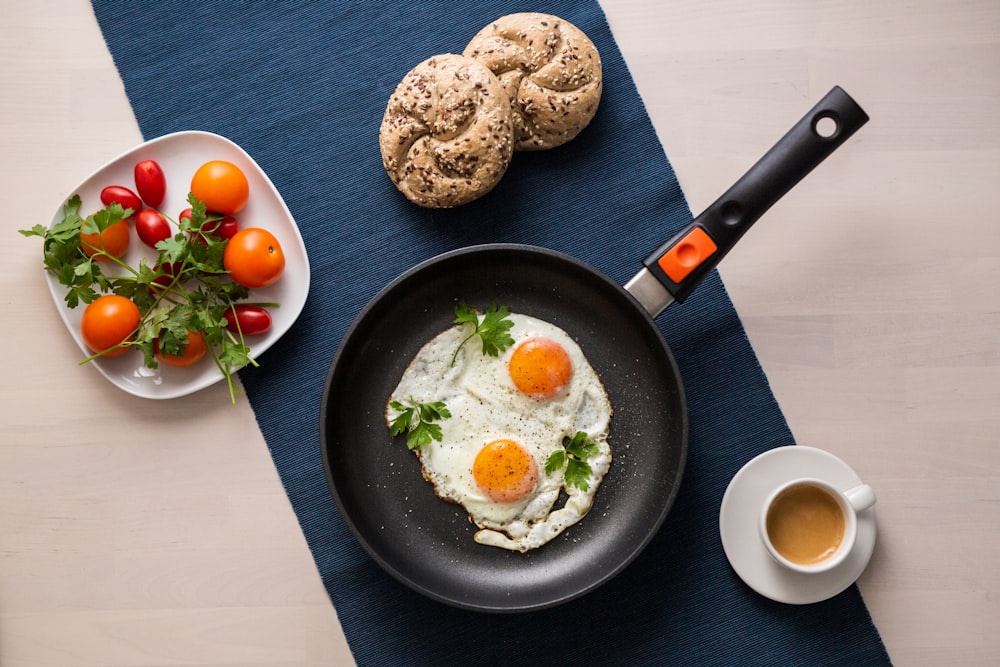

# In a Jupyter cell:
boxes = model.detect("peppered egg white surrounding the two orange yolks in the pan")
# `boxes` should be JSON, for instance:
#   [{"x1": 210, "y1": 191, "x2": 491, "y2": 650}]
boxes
[{"x1": 386, "y1": 313, "x2": 612, "y2": 552}]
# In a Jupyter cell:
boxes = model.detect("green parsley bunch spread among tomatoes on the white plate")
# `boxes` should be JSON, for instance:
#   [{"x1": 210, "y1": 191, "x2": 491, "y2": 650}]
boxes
[{"x1": 18, "y1": 195, "x2": 277, "y2": 402}]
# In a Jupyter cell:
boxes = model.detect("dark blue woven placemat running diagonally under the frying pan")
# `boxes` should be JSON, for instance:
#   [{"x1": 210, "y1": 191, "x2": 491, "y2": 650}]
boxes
[{"x1": 93, "y1": 0, "x2": 889, "y2": 666}]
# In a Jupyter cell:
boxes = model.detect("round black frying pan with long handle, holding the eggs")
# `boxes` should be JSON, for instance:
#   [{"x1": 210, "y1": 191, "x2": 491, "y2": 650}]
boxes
[{"x1": 320, "y1": 88, "x2": 868, "y2": 612}]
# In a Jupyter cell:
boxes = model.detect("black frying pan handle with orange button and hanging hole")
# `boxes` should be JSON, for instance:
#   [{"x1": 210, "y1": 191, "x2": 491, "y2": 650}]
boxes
[{"x1": 643, "y1": 86, "x2": 868, "y2": 301}]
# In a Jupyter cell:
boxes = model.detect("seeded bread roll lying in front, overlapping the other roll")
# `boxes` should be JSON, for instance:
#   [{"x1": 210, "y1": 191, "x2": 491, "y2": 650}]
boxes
[{"x1": 379, "y1": 54, "x2": 514, "y2": 208}]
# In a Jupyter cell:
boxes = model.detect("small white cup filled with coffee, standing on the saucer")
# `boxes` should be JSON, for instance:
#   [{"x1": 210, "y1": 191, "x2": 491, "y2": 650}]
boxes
[{"x1": 760, "y1": 477, "x2": 875, "y2": 574}]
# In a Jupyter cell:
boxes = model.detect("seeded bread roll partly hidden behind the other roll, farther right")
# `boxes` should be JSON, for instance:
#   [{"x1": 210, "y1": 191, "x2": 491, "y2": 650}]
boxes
[{"x1": 463, "y1": 13, "x2": 602, "y2": 151}]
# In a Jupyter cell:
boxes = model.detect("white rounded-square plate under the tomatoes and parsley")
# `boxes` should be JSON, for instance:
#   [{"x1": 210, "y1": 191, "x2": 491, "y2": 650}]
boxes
[{"x1": 46, "y1": 130, "x2": 309, "y2": 399}]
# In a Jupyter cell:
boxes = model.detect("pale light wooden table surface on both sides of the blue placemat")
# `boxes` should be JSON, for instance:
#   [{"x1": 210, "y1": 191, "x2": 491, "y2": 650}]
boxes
[{"x1": 0, "y1": 0, "x2": 1000, "y2": 667}]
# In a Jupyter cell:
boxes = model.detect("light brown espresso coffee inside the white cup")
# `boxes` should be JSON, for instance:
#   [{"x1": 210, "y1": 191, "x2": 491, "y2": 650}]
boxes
[{"x1": 766, "y1": 483, "x2": 845, "y2": 565}]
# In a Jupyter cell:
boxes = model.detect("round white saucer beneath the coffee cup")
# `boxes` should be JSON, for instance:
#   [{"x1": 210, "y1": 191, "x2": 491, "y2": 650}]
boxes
[{"x1": 719, "y1": 445, "x2": 875, "y2": 604}]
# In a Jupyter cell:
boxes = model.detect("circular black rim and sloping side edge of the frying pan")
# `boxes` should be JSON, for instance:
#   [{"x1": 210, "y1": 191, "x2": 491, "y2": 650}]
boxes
[{"x1": 319, "y1": 243, "x2": 689, "y2": 613}]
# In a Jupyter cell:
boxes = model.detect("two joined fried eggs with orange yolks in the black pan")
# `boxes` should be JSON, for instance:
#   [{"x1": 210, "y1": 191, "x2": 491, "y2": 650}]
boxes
[{"x1": 386, "y1": 313, "x2": 612, "y2": 552}]
